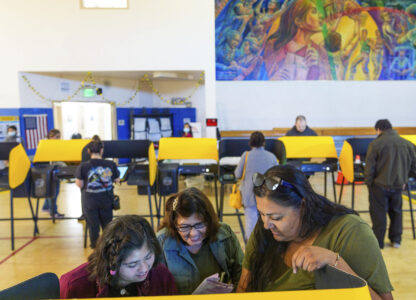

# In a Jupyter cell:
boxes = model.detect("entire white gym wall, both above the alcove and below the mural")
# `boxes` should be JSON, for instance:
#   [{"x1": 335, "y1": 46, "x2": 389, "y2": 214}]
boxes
[{"x1": 0, "y1": 0, "x2": 416, "y2": 136}]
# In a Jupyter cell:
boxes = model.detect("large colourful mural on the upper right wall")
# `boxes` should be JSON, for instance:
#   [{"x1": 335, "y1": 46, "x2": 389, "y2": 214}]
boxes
[{"x1": 215, "y1": 0, "x2": 416, "y2": 80}]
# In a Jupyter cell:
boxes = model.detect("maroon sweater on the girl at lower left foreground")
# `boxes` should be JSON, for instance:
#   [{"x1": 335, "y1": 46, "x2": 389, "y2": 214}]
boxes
[{"x1": 59, "y1": 263, "x2": 178, "y2": 299}]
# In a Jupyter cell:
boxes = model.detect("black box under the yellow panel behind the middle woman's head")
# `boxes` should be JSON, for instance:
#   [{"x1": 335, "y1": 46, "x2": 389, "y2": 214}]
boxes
[{"x1": 157, "y1": 164, "x2": 179, "y2": 196}]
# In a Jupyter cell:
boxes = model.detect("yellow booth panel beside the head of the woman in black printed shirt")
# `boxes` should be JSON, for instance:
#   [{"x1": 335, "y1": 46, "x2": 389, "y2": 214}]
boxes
[{"x1": 33, "y1": 140, "x2": 90, "y2": 162}]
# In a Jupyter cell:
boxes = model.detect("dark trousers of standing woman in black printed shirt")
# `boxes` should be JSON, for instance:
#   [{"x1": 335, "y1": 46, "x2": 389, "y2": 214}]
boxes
[{"x1": 82, "y1": 195, "x2": 113, "y2": 248}]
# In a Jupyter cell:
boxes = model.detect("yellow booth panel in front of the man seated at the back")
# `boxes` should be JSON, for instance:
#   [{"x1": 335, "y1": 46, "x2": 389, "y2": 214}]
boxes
[{"x1": 279, "y1": 136, "x2": 338, "y2": 158}]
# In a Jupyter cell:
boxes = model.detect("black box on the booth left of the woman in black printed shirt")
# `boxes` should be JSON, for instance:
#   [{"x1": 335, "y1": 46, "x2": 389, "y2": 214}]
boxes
[{"x1": 31, "y1": 164, "x2": 56, "y2": 198}]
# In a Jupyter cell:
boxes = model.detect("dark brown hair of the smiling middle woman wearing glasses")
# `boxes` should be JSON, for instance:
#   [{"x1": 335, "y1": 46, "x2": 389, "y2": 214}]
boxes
[{"x1": 160, "y1": 188, "x2": 220, "y2": 242}]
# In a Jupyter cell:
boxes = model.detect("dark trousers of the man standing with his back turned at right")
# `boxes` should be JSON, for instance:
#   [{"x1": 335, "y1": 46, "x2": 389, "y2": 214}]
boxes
[{"x1": 368, "y1": 184, "x2": 403, "y2": 249}]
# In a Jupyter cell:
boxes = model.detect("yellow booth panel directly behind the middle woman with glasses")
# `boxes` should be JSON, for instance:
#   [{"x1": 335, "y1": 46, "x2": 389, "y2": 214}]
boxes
[{"x1": 159, "y1": 138, "x2": 218, "y2": 161}]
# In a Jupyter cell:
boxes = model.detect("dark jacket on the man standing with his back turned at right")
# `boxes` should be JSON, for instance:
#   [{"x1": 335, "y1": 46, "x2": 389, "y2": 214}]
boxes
[{"x1": 364, "y1": 129, "x2": 416, "y2": 188}]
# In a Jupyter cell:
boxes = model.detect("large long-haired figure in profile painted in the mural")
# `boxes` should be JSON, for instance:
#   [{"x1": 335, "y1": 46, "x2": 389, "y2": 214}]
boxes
[{"x1": 264, "y1": 0, "x2": 329, "y2": 80}]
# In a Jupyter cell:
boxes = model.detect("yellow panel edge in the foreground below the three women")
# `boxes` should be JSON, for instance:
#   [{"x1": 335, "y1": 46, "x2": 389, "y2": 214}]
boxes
[{"x1": 94, "y1": 286, "x2": 371, "y2": 300}]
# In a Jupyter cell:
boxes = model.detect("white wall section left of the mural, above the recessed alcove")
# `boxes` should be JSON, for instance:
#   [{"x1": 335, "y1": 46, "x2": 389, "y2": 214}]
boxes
[{"x1": 0, "y1": 0, "x2": 216, "y2": 134}]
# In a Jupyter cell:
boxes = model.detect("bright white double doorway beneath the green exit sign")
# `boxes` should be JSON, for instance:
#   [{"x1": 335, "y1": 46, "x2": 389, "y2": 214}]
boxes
[{"x1": 53, "y1": 101, "x2": 117, "y2": 140}]
